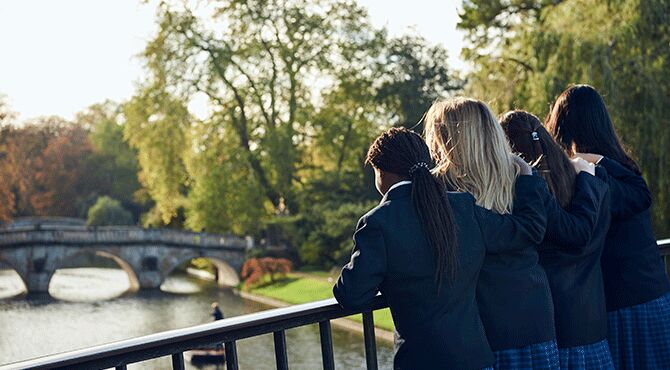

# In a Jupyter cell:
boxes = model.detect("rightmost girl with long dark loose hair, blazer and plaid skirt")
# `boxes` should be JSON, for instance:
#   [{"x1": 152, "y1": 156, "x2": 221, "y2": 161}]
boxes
[{"x1": 547, "y1": 85, "x2": 670, "y2": 369}]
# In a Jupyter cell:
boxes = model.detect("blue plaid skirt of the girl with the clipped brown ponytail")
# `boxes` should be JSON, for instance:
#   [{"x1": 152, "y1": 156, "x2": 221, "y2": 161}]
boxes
[{"x1": 558, "y1": 339, "x2": 614, "y2": 370}]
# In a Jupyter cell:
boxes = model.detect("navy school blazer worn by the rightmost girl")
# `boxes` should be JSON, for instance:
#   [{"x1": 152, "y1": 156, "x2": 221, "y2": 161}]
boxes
[{"x1": 599, "y1": 157, "x2": 670, "y2": 311}]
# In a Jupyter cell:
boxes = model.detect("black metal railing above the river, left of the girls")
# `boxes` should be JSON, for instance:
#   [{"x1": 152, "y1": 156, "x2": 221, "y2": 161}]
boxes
[{"x1": 0, "y1": 296, "x2": 388, "y2": 370}]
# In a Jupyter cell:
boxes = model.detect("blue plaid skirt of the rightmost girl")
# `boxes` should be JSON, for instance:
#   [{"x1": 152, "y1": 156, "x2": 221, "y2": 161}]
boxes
[{"x1": 607, "y1": 293, "x2": 670, "y2": 370}]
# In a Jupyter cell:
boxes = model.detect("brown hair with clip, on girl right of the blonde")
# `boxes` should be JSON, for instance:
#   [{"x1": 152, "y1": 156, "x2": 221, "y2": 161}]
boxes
[{"x1": 500, "y1": 110, "x2": 577, "y2": 208}]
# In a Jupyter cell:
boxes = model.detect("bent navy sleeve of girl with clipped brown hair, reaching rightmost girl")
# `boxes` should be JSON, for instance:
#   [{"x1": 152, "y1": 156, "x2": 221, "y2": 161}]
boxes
[{"x1": 540, "y1": 172, "x2": 608, "y2": 249}]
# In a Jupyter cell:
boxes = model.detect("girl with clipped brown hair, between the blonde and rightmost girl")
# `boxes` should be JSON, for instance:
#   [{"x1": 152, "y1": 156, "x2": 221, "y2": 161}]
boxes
[{"x1": 500, "y1": 111, "x2": 614, "y2": 370}]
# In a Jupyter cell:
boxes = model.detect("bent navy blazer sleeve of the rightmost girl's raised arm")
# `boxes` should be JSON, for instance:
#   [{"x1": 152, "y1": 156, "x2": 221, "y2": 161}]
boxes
[{"x1": 598, "y1": 157, "x2": 651, "y2": 218}]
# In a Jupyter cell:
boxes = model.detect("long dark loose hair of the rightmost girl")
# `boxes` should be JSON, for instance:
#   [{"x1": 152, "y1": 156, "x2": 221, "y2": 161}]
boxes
[{"x1": 546, "y1": 85, "x2": 640, "y2": 174}]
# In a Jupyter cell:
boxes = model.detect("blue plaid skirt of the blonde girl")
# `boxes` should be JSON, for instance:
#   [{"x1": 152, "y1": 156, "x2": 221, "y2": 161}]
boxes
[{"x1": 493, "y1": 340, "x2": 560, "y2": 370}]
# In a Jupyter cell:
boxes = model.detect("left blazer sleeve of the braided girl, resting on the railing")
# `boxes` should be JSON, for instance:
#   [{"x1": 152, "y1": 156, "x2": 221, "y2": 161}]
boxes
[{"x1": 333, "y1": 212, "x2": 386, "y2": 309}]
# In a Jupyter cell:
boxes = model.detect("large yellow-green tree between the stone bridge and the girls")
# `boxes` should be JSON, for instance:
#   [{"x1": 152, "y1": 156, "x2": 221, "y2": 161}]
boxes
[{"x1": 123, "y1": 0, "x2": 459, "y2": 264}]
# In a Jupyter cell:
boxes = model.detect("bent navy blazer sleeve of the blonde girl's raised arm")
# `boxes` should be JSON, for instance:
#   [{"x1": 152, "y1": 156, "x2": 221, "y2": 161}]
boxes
[{"x1": 475, "y1": 175, "x2": 549, "y2": 253}]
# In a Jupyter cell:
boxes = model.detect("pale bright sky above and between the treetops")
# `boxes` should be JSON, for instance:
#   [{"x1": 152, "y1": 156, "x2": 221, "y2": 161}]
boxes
[{"x1": 0, "y1": 0, "x2": 465, "y2": 120}]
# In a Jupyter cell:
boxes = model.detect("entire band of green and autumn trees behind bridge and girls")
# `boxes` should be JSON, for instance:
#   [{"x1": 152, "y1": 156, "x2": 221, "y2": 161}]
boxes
[{"x1": 0, "y1": 0, "x2": 670, "y2": 267}]
